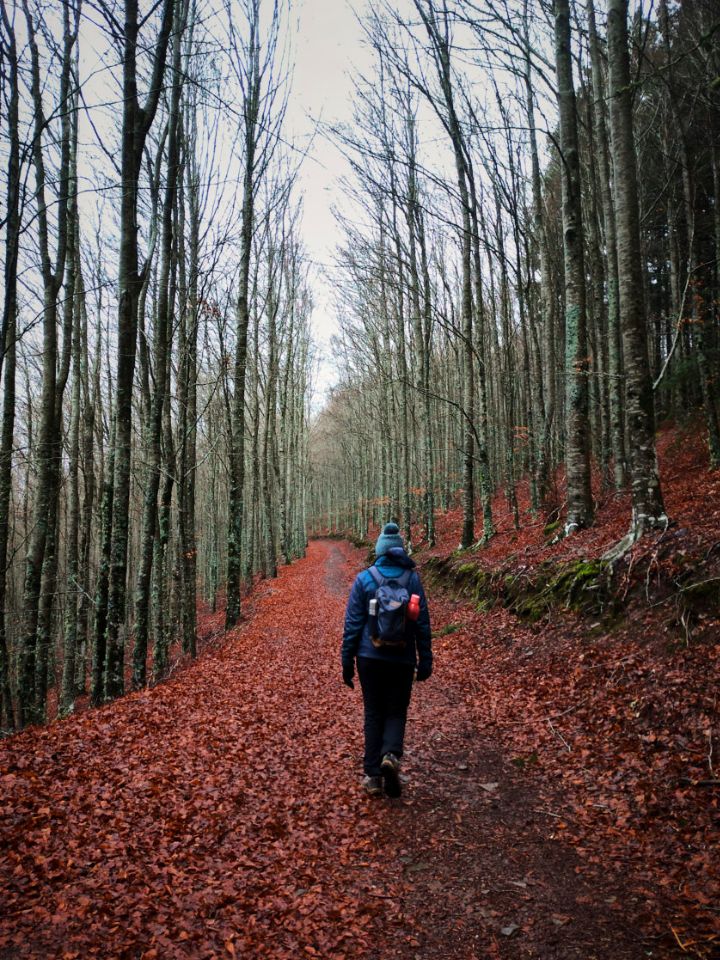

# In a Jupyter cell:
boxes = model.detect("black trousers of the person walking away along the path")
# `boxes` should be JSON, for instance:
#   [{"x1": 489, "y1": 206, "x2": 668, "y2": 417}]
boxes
[{"x1": 358, "y1": 657, "x2": 415, "y2": 777}]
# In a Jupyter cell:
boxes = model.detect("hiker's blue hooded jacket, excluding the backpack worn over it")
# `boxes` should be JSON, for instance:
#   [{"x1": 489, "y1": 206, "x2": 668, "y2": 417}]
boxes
[{"x1": 341, "y1": 547, "x2": 432, "y2": 670}]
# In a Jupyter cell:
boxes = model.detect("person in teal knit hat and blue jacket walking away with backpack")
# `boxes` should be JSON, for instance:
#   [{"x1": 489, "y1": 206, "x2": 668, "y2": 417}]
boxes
[{"x1": 342, "y1": 523, "x2": 432, "y2": 797}]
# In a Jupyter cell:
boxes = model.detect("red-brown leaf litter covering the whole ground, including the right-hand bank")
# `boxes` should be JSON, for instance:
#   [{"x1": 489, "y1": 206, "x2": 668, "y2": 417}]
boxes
[{"x1": 0, "y1": 424, "x2": 720, "y2": 960}]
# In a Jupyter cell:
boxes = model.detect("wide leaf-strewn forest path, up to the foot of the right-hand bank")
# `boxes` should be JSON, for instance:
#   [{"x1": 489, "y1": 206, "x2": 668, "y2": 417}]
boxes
[{"x1": 0, "y1": 541, "x2": 648, "y2": 960}]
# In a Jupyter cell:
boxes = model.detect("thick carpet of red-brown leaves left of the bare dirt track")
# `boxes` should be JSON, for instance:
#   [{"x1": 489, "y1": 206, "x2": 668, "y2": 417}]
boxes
[{"x1": 0, "y1": 545, "x2": 402, "y2": 960}]
